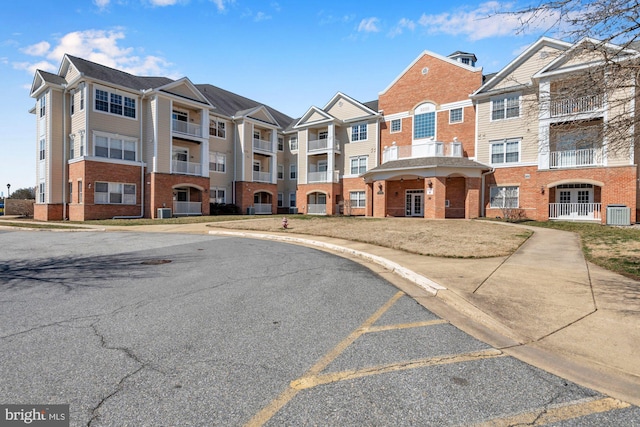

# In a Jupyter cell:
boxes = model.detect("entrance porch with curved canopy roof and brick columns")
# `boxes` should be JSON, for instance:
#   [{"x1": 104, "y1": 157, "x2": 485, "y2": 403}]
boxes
[{"x1": 363, "y1": 157, "x2": 491, "y2": 219}]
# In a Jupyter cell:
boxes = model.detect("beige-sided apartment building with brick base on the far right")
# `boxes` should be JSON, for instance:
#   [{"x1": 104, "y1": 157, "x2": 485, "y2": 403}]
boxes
[{"x1": 471, "y1": 37, "x2": 640, "y2": 223}]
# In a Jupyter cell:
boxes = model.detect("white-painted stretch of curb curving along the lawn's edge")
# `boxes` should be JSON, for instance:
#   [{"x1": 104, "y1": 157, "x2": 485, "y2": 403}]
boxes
[{"x1": 209, "y1": 230, "x2": 447, "y2": 296}]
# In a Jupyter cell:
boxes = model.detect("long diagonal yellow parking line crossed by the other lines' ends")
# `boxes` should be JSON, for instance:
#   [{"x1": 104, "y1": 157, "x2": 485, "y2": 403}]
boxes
[{"x1": 245, "y1": 291, "x2": 406, "y2": 427}]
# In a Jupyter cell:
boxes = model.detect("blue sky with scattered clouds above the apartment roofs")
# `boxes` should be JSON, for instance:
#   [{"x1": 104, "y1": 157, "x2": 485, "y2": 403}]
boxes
[{"x1": 0, "y1": 0, "x2": 556, "y2": 192}]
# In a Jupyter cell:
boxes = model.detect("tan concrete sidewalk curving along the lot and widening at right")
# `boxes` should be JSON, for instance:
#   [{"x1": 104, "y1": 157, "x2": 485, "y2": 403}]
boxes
[{"x1": 0, "y1": 221, "x2": 640, "y2": 405}]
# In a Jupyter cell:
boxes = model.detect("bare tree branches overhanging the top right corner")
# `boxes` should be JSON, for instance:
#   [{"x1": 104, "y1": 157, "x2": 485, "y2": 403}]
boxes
[{"x1": 501, "y1": 0, "x2": 640, "y2": 153}]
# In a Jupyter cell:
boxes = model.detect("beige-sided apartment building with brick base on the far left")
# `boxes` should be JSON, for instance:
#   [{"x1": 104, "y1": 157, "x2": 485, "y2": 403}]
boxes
[{"x1": 31, "y1": 55, "x2": 295, "y2": 221}]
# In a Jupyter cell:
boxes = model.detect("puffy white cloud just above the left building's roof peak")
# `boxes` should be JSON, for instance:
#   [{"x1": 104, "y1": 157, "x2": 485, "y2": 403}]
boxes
[{"x1": 13, "y1": 30, "x2": 175, "y2": 78}]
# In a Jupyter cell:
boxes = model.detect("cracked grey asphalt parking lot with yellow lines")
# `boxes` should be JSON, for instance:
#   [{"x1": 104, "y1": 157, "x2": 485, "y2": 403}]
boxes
[{"x1": 0, "y1": 231, "x2": 640, "y2": 426}]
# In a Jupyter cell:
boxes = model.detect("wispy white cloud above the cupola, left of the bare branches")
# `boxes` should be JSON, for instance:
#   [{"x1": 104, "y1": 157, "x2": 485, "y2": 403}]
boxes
[{"x1": 418, "y1": 1, "x2": 554, "y2": 40}]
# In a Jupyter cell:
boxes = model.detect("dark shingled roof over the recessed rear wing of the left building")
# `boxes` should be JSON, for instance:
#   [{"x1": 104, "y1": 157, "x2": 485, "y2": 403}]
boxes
[{"x1": 195, "y1": 84, "x2": 293, "y2": 129}]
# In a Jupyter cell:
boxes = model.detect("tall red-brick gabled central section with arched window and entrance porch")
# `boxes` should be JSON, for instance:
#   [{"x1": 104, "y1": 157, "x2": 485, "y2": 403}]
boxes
[{"x1": 362, "y1": 51, "x2": 491, "y2": 218}]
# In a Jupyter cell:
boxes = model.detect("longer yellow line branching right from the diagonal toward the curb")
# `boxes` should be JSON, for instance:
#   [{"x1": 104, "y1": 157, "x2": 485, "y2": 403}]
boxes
[{"x1": 291, "y1": 348, "x2": 506, "y2": 390}]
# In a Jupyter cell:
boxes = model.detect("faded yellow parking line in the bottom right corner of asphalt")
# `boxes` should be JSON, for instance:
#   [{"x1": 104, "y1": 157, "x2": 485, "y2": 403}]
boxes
[{"x1": 474, "y1": 397, "x2": 631, "y2": 427}]
